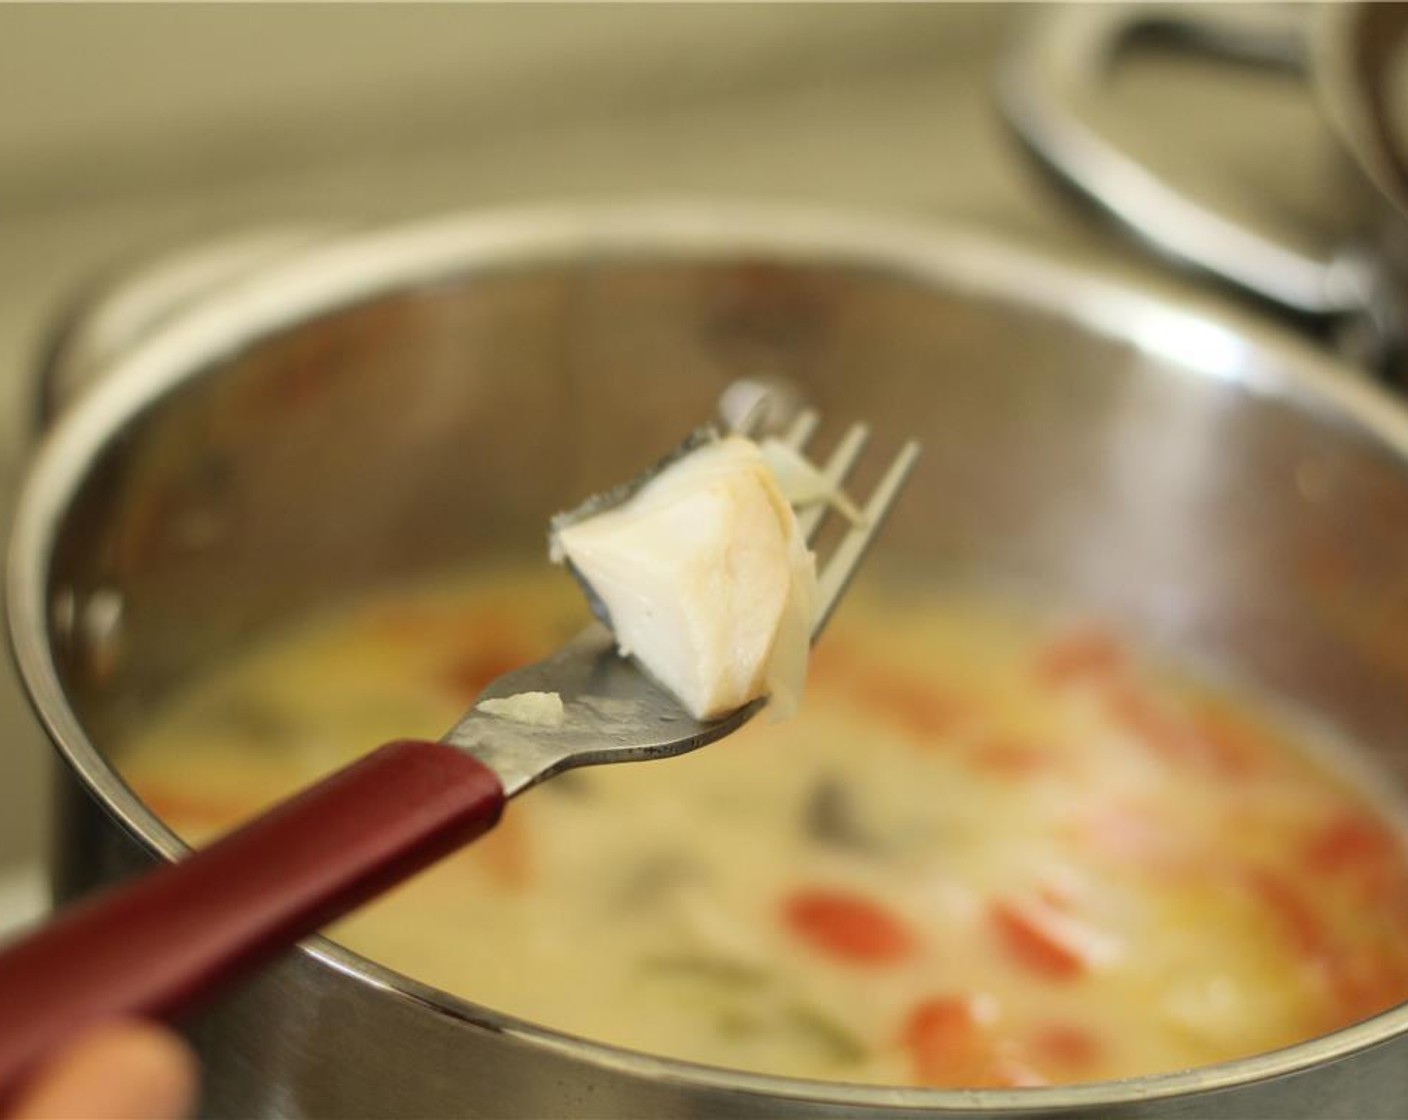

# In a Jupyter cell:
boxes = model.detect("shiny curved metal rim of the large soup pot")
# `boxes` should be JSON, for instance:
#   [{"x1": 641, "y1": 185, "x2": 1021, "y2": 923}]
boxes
[{"x1": 16, "y1": 200, "x2": 1408, "y2": 1113}]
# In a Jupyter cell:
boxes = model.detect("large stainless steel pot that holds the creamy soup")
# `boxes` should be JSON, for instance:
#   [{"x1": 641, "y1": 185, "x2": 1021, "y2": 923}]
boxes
[{"x1": 8, "y1": 206, "x2": 1408, "y2": 1117}]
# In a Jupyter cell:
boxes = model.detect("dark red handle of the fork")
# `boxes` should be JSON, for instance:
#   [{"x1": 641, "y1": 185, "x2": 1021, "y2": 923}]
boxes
[{"x1": 0, "y1": 740, "x2": 504, "y2": 1105}]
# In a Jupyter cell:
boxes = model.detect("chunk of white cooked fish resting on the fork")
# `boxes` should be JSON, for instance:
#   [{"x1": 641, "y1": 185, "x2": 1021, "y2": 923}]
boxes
[{"x1": 552, "y1": 433, "x2": 817, "y2": 720}]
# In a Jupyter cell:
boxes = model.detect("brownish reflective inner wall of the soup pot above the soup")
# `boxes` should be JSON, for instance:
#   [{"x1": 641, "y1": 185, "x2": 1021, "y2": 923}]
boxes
[{"x1": 41, "y1": 258, "x2": 1408, "y2": 788}]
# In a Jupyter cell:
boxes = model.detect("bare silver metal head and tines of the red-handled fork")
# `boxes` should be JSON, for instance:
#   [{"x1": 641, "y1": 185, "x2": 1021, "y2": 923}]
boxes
[{"x1": 442, "y1": 409, "x2": 919, "y2": 797}]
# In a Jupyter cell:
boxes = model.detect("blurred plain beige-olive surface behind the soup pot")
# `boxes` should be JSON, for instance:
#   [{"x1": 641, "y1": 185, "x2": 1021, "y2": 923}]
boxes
[{"x1": 0, "y1": 3, "x2": 1338, "y2": 927}]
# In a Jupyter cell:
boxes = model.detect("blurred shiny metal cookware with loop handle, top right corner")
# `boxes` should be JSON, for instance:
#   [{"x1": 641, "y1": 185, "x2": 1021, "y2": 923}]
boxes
[{"x1": 1000, "y1": 3, "x2": 1408, "y2": 383}]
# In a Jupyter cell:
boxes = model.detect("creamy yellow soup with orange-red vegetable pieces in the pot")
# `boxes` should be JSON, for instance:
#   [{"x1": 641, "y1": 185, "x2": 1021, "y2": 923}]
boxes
[{"x1": 122, "y1": 566, "x2": 1408, "y2": 1086}]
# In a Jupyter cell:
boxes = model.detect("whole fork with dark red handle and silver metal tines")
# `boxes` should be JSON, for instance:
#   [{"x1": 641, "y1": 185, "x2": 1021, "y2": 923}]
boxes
[{"x1": 0, "y1": 413, "x2": 917, "y2": 1110}]
